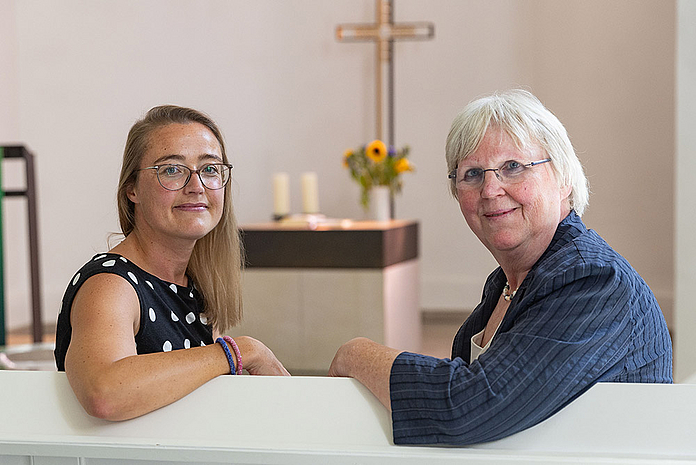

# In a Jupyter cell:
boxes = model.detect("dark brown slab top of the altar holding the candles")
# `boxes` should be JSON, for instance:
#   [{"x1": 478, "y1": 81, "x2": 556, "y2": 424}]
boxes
[{"x1": 241, "y1": 220, "x2": 418, "y2": 269}]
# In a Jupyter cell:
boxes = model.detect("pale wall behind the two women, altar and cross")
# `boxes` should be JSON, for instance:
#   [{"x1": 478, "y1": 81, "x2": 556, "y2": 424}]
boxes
[{"x1": 0, "y1": 0, "x2": 674, "y2": 334}]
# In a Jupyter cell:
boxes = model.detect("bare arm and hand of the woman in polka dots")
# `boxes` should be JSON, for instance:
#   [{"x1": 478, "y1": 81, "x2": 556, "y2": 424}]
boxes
[{"x1": 65, "y1": 274, "x2": 287, "y2": 420}]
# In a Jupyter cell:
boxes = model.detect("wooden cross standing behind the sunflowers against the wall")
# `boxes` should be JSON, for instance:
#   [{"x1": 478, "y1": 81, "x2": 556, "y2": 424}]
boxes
[{"x1": 336, "y1": 0, "x2": 435, "y2": 145}]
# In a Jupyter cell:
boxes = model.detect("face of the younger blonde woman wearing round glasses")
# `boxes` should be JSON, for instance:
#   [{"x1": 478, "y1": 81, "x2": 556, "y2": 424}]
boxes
[{"x1": 127, "y1": 123, "x2": 225, "y2": 245}]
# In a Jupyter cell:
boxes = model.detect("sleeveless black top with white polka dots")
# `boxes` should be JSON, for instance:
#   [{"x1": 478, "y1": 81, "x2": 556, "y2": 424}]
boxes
[{"x1": 54, "y1": 253, "x2": 213, "y2": 371}]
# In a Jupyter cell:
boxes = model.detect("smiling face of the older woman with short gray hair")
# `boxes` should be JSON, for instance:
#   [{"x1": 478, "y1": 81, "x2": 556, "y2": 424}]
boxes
[{"x1": 457, "y1": 126, "x2": 570, "y2": 263}]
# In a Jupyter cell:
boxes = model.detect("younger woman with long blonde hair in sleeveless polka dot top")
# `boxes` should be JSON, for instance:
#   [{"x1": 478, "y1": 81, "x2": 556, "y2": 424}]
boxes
[{"x1": 55, "y1": 105, "x2": 288, "y2": 420}]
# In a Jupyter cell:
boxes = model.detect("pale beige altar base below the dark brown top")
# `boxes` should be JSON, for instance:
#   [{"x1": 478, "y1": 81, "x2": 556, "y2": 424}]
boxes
[{"x1": 237, "y1": 260, "x2": 421, "y2": 374}]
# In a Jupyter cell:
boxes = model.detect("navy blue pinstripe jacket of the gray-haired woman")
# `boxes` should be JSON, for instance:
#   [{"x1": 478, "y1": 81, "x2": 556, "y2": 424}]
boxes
[{"x1": 390, "y1": 212, "x2": 672, "y2": 445}]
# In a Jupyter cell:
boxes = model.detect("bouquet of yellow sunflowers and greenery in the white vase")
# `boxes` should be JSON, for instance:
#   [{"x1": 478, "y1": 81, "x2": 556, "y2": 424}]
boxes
[{"x1": 343, "y1": 140, "x2": 414, "y2": 209}]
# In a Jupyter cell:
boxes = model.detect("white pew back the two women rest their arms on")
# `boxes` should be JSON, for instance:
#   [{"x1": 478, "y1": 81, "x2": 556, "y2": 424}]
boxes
[{"x1": 0, "y1": 371, "x2": 696, "y2": 465}]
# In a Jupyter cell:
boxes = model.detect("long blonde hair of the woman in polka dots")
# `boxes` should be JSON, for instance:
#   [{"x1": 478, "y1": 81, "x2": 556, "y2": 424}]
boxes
[{"x1": 116, "y1": 105, "x2": 243, "y2": 333}]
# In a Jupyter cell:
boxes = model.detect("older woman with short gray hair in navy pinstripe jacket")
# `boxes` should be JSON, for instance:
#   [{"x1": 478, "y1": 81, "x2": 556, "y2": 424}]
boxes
[{"x1": 329, "y1": 90, "x2": 672, "y2": 445}]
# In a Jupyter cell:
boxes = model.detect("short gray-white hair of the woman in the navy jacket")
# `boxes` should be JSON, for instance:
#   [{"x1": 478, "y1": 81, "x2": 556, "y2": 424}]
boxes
[{"x1": 445, "y1": 89, "x2": 590, "y2": 216}]
